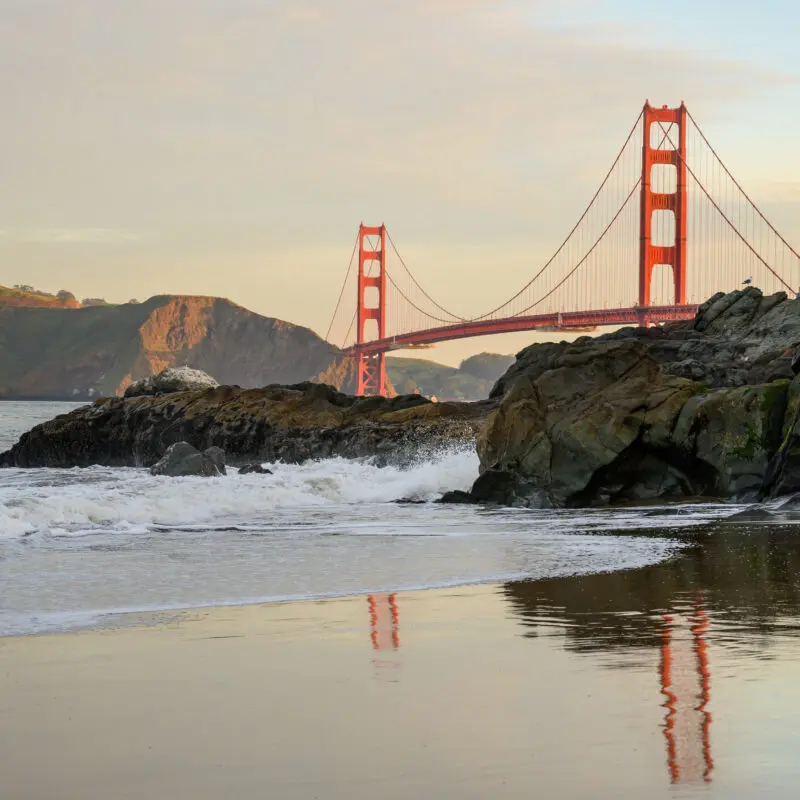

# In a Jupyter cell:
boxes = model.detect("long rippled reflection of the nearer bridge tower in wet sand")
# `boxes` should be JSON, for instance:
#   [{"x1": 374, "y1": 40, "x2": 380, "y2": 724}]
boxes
[{"x1": 661, "y1": 603, "x2": 714, "y2": 784}]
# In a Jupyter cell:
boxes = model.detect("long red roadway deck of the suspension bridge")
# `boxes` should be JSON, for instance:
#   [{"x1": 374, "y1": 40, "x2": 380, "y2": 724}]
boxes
[{"x1": 344, "y1": 305, "x2": 698, "y2": 356}]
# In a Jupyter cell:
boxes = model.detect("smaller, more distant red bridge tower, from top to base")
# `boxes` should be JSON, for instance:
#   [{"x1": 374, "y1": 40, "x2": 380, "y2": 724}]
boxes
[{"x1": 356, "y1": 223, "x2": 387, "y2": 396}]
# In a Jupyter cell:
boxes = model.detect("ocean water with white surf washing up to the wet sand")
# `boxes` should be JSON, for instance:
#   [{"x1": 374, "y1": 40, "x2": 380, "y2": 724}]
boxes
[{"x1": 0, "y1": 402, "x2": 735, "y2": 635}]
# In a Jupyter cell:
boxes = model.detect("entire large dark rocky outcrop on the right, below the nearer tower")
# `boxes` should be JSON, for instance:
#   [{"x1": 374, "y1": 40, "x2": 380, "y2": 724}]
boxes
[{"x1": 462, "y1": 288, "x2": 800, "y2": 507}]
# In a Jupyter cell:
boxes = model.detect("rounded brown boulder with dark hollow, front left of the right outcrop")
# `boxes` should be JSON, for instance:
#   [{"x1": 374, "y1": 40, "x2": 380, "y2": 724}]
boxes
[{"x1": 482, "y1": 340, "x2": 706, "y2": 506}]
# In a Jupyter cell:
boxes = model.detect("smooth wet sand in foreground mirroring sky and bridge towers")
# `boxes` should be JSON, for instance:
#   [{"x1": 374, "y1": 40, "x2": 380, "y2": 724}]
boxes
[{"x1": 0, "y1": 529, "x2": 800, "y2": 800}]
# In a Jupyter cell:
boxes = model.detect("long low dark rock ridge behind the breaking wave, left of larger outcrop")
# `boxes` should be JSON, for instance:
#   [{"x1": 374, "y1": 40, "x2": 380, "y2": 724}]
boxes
[{"x1": 0, "y1": 383, "x2": 494, "y2": 467}]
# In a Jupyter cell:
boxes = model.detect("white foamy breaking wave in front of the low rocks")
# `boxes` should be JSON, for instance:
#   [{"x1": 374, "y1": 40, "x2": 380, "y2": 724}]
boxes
[{"x1": 0, "y1": 447, "x2": 478, "y2": 538}]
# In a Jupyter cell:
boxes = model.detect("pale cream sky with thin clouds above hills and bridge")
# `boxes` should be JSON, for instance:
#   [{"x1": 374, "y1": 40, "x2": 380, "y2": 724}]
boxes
[{"x1": 0, "y1": 0, "x2": 800, "y2": 363}]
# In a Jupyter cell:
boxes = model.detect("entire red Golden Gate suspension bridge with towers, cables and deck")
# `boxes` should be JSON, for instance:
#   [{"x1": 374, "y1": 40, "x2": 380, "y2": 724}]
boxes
[{"x1": 326, "y1": 103, "x2": 800, "y2": 395}]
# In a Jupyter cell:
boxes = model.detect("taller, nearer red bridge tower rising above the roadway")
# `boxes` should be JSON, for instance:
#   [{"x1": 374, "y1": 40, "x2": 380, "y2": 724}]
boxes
[{"x1": 639, "y1": 103, "x2": 688, "y2": 308}]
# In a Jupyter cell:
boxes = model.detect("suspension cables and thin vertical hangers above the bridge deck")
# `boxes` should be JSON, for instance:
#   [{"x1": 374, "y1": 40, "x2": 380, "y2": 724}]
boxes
[{"x1": 326, "y1": 105, "x2": 800, "y2": 347}]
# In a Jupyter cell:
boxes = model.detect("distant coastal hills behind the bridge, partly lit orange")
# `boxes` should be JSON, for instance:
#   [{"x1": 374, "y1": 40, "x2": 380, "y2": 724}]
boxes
[{"x1": 0, "y1": 287, "x2": 511, "y2": 400}]
